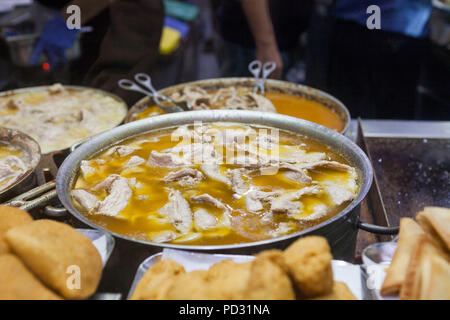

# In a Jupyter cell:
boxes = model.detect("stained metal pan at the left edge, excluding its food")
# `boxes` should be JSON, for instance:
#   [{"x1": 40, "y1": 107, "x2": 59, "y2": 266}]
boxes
[{"x1": 0, "y1": 127, "x2": 41, "y2": 202}]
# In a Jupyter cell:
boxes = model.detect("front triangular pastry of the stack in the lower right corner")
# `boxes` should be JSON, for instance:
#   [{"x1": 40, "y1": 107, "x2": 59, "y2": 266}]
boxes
[{"x1": 400, "y1": 235, "x2": 450, "y2": 300}]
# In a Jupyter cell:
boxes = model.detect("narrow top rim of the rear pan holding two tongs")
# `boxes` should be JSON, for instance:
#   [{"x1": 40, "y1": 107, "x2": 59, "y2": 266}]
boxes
[{"x1": 125, "y1": 77, "x2": 350, "y2": 134}]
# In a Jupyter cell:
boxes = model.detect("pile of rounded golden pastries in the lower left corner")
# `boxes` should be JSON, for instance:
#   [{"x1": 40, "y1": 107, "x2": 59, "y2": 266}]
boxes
[{"x1": 0, "y1": 206, "x2": 102, "y2": 300}]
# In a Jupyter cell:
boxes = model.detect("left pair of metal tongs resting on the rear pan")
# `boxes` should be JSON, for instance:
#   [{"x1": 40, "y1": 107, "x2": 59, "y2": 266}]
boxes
[{"x1": 118, "y1": 73, "x2": 192, "y2": 113}]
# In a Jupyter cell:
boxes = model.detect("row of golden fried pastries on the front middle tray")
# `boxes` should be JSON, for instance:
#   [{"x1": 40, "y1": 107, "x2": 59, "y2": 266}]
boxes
[{"x1": 131, "y1": 236, "x2": 355, "y2": 300}]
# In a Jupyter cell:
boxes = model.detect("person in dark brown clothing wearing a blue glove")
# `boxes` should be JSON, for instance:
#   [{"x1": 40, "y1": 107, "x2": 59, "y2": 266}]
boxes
[{"x1": 35, "y1": 0, "x2": 164, "y2": 105}]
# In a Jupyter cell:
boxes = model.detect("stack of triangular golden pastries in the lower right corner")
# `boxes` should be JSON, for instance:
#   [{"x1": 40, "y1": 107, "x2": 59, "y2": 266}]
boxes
[{"x1": 381, "y1": 207, "x2": 450, "y2": 300}]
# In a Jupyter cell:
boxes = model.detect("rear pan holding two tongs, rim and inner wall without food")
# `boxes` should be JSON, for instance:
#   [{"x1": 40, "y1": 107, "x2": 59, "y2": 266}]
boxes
[{"x1": 125, "y1": 78, "x2": 350, "y2": 134}]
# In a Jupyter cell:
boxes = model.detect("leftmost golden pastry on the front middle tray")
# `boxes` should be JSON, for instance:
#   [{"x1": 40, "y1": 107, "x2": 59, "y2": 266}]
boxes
[{"x1": 131, "y1": 259, "x2": 186, "y2": 300}]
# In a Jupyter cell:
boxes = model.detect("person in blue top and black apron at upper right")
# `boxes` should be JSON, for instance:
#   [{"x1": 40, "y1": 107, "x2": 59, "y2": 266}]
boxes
[{"x1": 306, "y1": 0, "x2": 431, "y2": 119}]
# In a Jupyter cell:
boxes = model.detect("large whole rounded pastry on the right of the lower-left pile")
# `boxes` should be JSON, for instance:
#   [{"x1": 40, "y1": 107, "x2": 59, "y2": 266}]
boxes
[{"x1": 5, "y1": 220, "x2": 102, "y2": 299}]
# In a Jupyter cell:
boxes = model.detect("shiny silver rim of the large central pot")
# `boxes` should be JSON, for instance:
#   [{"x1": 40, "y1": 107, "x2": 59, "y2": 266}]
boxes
[{"x1": 56, "y1": 110, "x2": 373, "y2": 251}]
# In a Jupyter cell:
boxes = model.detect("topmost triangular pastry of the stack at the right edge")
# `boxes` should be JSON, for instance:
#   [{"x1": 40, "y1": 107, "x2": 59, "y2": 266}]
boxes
[{"x1": 416, "y1": 207, "x2": 450, "y2": 251}]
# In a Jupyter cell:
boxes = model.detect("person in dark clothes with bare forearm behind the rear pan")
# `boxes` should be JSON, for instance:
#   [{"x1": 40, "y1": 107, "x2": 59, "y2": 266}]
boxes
[{"x1": 213, "y1": 0, "x2": 313, "y2": 79}]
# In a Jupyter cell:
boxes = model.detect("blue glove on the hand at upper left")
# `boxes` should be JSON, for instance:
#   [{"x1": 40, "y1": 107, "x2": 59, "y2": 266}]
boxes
[{"x1": 30, "y1": 14, "x2": 80, "y2": 68}]
